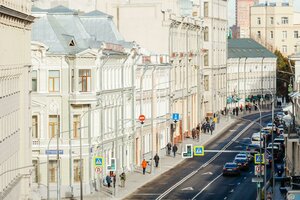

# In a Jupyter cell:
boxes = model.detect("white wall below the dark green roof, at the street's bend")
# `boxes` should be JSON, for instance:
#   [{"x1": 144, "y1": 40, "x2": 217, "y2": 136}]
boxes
[{"x1": 227, "y1": 58, "x2": 276, "y2": 106}]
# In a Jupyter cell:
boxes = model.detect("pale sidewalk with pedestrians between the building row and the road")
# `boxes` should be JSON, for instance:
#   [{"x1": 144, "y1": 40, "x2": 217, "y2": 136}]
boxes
[{"x1": 81, "y1": 111, "x2": 257, "y2": 200}]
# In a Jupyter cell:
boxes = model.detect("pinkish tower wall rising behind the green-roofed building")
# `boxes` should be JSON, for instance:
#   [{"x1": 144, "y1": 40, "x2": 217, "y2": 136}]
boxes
[{"x1": 236, "y1": 0, "x2": 257, "y2": 38}]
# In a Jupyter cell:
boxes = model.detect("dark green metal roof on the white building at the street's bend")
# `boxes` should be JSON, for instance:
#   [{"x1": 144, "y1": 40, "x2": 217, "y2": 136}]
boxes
[{"x1": 228, "y1": 38, "x2": 276, "y2": 58}]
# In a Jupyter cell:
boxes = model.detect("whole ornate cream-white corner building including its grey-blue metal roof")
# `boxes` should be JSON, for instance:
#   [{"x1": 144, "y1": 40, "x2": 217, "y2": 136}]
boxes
[{"x1": 31, "y1": 7, "x2": 137, "y2": 199}]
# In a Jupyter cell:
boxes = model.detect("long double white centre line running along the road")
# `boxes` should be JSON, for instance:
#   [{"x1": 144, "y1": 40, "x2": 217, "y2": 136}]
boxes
[{"x1": 156, "y1": 115, "x2": 270, "y2": 200}]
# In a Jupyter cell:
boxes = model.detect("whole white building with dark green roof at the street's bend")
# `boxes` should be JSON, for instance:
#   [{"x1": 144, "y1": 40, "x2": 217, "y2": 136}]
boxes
[{"x1": 227, "y1": 39, "x2": 277, "y2": 107}]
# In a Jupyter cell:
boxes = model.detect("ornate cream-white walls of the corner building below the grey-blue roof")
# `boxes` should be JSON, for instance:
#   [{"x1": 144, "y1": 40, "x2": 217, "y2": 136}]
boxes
[{"x1": 32, "y1": 42, "x2": 135, "y2": 198}]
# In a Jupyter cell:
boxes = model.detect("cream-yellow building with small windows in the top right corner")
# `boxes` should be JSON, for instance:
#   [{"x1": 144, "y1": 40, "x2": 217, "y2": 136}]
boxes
[{"x1": 250, "y1": 4, "x2": 300, "y2": 56}]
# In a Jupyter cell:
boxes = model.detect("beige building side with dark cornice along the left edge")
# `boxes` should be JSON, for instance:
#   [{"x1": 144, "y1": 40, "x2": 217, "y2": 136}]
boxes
[{"x1": 0, "y1": 0, "x2": 34, "y2": 200}]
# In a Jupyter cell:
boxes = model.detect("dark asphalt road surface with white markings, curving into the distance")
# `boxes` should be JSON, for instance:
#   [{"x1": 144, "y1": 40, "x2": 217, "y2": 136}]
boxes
[{"x1": 126, "y1": 113, "x2": 271, "y2": 200}]
